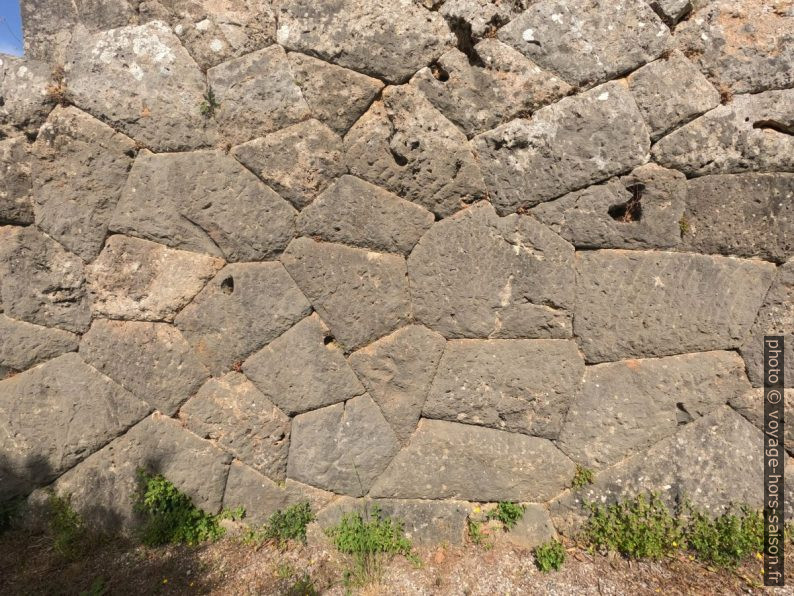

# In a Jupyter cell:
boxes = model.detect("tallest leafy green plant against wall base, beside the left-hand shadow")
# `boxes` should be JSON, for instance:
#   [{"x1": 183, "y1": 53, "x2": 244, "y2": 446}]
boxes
[{"x1": 135, "y1": 470, "x2": 245, "y2": 546}]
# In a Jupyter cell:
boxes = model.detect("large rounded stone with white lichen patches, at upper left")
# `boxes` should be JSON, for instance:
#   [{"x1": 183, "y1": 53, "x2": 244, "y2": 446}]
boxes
[{"x1": 65, "y1": 21, "x2": 214, "y2": 151}]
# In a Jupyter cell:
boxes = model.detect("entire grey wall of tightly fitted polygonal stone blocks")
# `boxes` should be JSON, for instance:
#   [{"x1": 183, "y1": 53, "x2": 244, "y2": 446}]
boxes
[{"x1": 0, "y1": 0, "x2": 794, "y2": 543}]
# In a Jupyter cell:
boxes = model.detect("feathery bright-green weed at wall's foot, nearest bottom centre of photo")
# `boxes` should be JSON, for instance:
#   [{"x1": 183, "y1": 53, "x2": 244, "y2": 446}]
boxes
[{"x1": 325, "y1": 505, "x2": 419, "y2": 586}]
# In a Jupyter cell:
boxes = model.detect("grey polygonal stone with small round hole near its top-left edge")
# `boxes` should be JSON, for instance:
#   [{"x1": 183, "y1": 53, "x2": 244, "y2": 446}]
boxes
[{"x1": 175, "y1": 262, "x2": 311, "y2": 375}]
